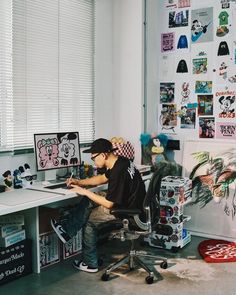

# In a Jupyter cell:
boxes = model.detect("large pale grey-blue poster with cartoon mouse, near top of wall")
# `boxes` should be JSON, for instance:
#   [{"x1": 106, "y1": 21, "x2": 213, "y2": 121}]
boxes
[{"x1": 191, "y1": 7, "x2": 213, "y2": 43}]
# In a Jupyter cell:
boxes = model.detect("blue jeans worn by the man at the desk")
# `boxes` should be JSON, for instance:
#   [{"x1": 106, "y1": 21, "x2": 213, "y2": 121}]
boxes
[{"x1": 61, "y1": 197, "x2": 98, "y2": 267}]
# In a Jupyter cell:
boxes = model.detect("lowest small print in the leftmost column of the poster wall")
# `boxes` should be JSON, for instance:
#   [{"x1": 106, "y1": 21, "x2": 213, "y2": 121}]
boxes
[{"x1": 160, "y1": 103, "x2": 177, "y2": 131}]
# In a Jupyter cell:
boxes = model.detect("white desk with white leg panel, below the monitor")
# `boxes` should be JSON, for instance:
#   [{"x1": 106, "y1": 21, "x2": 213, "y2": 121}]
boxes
[{"x1": 0, "y1": 183, "x2": 107, "y2": 273}]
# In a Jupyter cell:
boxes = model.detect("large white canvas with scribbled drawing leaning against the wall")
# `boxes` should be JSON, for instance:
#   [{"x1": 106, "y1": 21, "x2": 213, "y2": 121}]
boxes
[{"x1": 183, "y1": 141, "x2": 236, "y2": 239}]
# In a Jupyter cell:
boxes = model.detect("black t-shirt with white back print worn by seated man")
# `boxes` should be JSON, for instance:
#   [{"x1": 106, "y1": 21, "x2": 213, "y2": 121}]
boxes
[{"x1": 105, "y1": 157, "x2": 146, "y2": 210}]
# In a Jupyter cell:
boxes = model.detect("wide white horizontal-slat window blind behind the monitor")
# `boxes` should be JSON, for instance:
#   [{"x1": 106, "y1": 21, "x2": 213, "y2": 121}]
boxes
[{"x1": 1, "y1": 0, "x2": 95, "y2": 153}]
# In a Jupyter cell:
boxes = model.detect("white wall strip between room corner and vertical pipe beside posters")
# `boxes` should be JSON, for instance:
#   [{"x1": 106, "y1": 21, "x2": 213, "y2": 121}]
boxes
[{"x1": 113, "y1": 0, "x2": 143, "y2": 162}]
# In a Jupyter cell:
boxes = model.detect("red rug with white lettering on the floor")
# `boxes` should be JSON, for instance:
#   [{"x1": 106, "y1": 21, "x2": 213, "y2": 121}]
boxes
[{"x1": 198, "y1": 240, "x2": 236, "y2": 263}]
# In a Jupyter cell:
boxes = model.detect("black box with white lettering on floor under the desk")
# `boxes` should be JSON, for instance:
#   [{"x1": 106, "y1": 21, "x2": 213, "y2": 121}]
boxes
[{"x1": 0, "y1": 239, "x2": 32, "y2": 286}]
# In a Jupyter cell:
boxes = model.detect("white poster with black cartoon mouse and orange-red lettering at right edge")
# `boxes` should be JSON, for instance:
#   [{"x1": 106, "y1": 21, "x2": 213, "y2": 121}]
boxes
[{"x1": 215, "y1": 90, "x2": 236, "y2": 120}]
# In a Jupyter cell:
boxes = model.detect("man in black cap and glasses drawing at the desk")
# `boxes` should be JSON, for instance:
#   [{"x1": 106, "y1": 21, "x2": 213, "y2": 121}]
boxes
[{"x1": 51, "y1": 138, "x2": 145, "y2": 272}]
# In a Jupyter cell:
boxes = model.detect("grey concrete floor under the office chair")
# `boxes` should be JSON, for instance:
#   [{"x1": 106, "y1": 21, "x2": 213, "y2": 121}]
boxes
[{"x1": 0, "y1": 237, "x2": 236, "y2": 295}]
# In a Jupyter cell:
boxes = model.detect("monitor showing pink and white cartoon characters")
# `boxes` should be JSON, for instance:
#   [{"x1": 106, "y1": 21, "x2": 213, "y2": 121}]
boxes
[{"x1": 34, "y1": 132, "x2": 81, "y2": 171}]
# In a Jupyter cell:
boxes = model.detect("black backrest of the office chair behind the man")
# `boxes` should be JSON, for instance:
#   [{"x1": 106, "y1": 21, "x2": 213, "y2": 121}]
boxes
[{"x1": 144, "y1": 161, "x2": 181, "y2": 229}]
